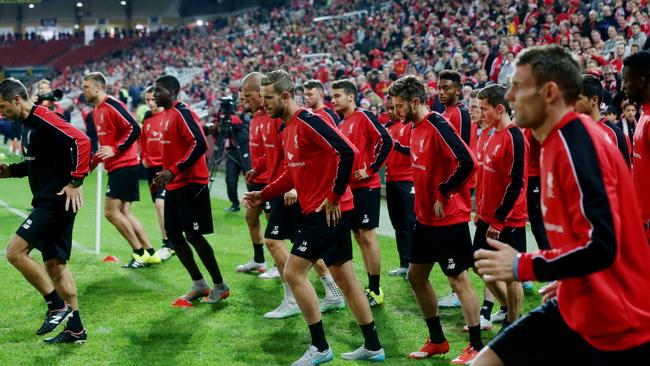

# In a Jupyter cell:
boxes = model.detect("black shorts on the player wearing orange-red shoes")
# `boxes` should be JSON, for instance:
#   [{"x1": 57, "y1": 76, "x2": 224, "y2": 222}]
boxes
[{"x1": 409, "y1": 222, "x2": 474, "y2": 277}]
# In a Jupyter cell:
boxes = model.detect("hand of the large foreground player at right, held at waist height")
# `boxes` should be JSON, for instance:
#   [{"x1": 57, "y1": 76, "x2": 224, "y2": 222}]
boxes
[{"x1": 474, "y1": 239, "x2": 517, "y2": 282}]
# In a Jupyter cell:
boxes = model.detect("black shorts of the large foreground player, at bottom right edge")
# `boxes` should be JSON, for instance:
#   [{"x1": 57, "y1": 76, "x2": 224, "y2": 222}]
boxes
[{"x1": 488, "y1": 299, "x2": 650, "y2": 366}]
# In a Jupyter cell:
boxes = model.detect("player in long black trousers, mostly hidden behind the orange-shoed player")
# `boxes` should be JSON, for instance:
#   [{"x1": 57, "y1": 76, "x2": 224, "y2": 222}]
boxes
[{"x1": 385, "y1": 97, "x2": 415, "y2": 276}]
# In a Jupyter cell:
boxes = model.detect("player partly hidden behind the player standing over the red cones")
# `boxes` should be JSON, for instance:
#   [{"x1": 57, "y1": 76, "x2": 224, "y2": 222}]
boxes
[{"x1": 140, "y1": 86, "x2": 175, "y2": 261}]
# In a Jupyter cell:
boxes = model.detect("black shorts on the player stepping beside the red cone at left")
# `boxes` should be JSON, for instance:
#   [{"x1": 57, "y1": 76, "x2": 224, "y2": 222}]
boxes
[{"x1": 165, "y1": 183, "x2": 213, "y2": 234}]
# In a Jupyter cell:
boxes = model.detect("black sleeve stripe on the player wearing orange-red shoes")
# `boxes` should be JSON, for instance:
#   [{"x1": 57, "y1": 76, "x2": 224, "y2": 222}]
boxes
[{"x1": 427, "y1": 113, "x2": 474, "y2": 196}]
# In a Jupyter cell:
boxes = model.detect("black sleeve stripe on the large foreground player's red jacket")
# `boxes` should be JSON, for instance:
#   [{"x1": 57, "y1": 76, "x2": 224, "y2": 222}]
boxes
[{"x1": 533, "y1": 119, "x2": 617, "y2": 281}]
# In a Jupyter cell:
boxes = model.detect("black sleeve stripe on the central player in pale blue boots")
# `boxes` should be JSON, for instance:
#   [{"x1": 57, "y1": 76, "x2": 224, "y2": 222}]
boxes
[{"x1": 298, "y1": 110, "x2": 354, "y2": 195}]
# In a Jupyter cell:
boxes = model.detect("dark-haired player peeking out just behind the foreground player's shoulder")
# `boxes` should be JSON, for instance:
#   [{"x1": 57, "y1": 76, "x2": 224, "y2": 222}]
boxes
[{"x1": 575, "y1": 74, "x2": 630, "y2": 167}]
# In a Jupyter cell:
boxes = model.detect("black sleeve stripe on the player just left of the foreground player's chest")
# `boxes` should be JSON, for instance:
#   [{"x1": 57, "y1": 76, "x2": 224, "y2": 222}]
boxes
[{"x1": 494, "y1": 128, "x2": 526, "y2": 221}]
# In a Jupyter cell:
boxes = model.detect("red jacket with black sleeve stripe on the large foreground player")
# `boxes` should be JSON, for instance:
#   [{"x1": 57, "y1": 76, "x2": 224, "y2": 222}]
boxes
[{"x1": 515, "y1": 112, "x2": 650, "y2": 351}]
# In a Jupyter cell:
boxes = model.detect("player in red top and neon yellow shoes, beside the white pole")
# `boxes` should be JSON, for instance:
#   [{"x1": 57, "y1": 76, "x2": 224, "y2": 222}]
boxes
[{"x1": 83, "y1": 72, "x2": 161, "y2": 268}]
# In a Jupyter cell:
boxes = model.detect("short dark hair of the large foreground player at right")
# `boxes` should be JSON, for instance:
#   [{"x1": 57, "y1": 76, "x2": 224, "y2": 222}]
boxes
[{"x1": 516, "y1": 45, "x2": 582, "y2": 104}]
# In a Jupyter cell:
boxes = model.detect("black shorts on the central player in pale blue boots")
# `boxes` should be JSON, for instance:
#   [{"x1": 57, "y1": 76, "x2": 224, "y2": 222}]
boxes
[{"x1": 291, "y1": 211, "x2": 352, "y2": 266}]
